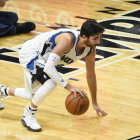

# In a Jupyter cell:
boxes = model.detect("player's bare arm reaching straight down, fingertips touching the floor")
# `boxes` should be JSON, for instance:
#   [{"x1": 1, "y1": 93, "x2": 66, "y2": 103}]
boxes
[{"x1": 85, "y1": 49, "x2": 107, "y2": 116}]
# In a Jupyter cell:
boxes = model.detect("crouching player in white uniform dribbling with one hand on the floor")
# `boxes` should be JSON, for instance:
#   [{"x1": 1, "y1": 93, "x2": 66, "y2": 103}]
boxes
[{"x1": 0, "y1": 20, "x2": 107, "y2": 131}]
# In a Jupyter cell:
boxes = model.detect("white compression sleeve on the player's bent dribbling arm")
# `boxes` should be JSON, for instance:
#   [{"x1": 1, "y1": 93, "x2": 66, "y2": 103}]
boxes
[{"x1": 44, "y1": 53, "x2": 68, "y2": 88}]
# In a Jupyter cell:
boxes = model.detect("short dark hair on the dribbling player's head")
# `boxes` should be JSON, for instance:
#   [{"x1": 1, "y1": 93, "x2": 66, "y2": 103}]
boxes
[{"x1": 80, "y1": 19, "x2": 105, "y2": 38}]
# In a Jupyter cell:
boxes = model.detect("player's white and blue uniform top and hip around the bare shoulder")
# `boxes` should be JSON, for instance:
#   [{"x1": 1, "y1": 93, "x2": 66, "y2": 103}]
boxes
[{"x1": 19, "y1": 29, "x2": 92, "y2": 73}]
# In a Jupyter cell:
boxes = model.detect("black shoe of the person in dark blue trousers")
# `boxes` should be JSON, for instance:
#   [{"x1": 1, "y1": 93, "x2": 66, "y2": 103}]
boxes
[{"x1": 15, "y1": 22, "x2": 36, "y2": 34}]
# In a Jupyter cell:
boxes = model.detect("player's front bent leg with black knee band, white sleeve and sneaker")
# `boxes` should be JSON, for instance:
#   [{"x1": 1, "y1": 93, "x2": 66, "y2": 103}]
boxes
[{"x1": 22, "y1": 73, "x2": 56, "y2": 132}]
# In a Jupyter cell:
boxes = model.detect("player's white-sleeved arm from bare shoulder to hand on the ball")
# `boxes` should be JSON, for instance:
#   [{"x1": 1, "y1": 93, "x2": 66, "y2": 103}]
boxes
[{"x1": 44, "y1": 33, "x2": 86, "y2": 96}]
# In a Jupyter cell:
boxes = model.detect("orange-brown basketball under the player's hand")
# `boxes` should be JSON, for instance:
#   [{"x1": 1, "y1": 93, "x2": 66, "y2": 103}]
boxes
[{"x1": 65, "y1": 93, "x2": 89, "y2": 115}]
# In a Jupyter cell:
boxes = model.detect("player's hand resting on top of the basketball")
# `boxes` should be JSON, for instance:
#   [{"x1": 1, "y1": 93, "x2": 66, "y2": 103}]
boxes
[{"x1": 65, "y1": 84, "x2": 87, "y2": 97}]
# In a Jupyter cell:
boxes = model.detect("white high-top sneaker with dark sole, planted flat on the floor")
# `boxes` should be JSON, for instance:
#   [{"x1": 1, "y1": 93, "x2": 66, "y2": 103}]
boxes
[{"x1": 21, "y1": 107, "x2": 41, "y2": 132}]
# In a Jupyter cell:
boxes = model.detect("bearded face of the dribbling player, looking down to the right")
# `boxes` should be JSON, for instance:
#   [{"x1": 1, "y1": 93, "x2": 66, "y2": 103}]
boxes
[{"x1": 85, "y1": 33, "x2": 101, "y2": 48}]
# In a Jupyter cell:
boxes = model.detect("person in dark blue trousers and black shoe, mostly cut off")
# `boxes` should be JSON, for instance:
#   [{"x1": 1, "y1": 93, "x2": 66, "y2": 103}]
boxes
[{"x1": 0, "y1": 0, "x2": 36, "y2": 37}]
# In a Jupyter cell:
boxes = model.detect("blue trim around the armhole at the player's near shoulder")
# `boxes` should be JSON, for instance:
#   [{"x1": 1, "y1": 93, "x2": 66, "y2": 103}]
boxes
[{"x1": 49, "y1": 31, "x2": 76, "y2": 50}]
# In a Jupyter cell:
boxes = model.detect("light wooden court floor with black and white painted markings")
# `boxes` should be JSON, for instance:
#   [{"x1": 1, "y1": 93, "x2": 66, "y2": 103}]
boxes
[{"x1": 0, "y1": 0, "x2": 140, "y2": 140}]
